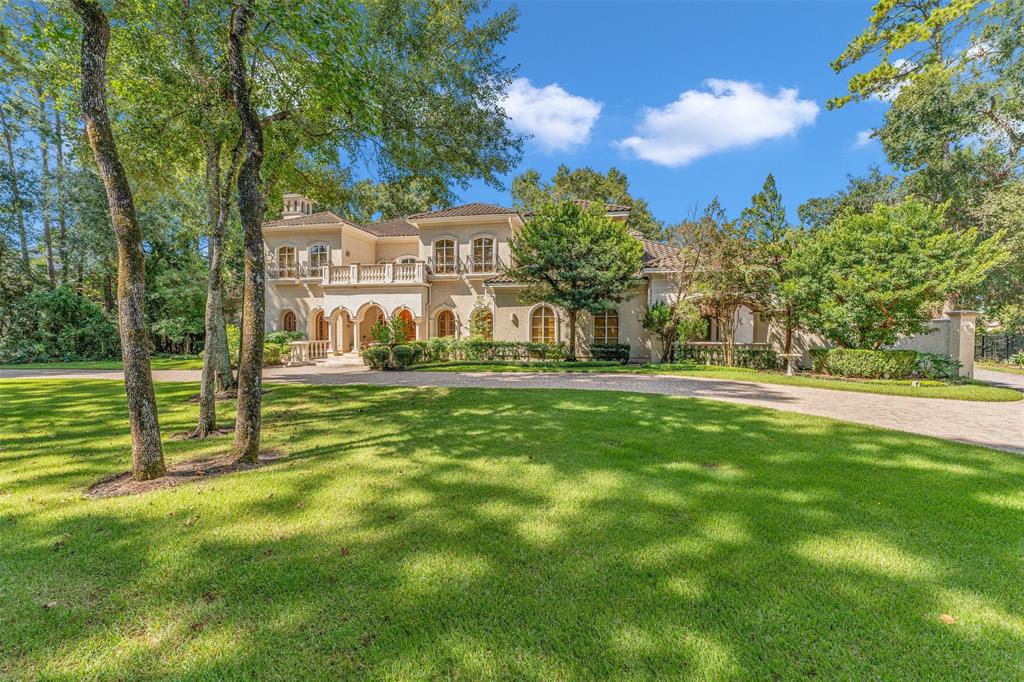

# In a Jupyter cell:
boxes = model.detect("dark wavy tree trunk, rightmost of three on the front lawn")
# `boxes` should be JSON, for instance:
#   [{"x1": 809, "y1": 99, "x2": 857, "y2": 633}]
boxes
[{"x1": 227, "y1": 0, "x2": 266, "y2": 462}]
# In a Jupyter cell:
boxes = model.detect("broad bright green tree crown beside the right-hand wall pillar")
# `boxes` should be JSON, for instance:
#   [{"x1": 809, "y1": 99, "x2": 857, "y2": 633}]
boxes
[{"x1": 794, "y1": 200, "x2": 1008, "y2": 348}]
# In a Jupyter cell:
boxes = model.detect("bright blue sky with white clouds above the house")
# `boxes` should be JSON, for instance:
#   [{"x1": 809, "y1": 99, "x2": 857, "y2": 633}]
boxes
[{"x1": 462, "y1": 0, "x2": 887, "y2": 221}]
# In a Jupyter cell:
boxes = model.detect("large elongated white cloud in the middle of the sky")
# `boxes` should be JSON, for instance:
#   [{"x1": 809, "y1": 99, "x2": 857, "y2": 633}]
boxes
[{"x1": 616, "y1": 78, "x2": 820, "y2": 166}]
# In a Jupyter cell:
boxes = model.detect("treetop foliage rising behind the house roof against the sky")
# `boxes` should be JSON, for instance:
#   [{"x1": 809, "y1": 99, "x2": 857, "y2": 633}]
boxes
[{"x1": 512, "y1": 165, "x2": 663, "y2": 239}]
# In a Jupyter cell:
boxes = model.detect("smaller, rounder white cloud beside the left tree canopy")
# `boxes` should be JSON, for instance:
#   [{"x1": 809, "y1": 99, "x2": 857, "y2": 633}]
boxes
[{"x1": 503, "y1": 78, "x2": 601, "y2": 152}]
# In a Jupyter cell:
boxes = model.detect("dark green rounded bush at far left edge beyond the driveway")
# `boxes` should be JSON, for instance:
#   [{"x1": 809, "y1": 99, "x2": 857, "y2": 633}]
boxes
[{"x1": 0, "y1": 287, "x2": 121, "y2": 364}]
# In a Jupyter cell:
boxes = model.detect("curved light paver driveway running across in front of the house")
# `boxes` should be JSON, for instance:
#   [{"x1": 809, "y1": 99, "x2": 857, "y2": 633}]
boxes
[{"x1": 0, "y1": 367, "x2": 1024, "y2": 454}]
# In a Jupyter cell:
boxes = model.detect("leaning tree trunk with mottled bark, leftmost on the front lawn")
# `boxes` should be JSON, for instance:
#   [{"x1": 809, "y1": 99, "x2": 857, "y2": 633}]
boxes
[{"x1": 72, "y1": 0, "x2": 166, "y2": 480}]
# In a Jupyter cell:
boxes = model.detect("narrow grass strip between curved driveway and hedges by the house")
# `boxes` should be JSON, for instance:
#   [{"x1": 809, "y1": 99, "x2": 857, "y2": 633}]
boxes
[{"x1": 414, "y1": 361, "x2": 1024, "y2": 402}]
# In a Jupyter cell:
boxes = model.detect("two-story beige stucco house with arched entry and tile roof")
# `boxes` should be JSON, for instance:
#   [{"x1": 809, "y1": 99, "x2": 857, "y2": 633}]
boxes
[{"x1": 263, "y1": 194, "x2": 770, "y2": 360}]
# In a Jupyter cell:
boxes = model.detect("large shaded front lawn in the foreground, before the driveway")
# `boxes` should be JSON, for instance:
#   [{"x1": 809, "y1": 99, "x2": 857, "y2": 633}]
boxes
[{"x1": 0, "y1": 380, "x2": 1024, "y2": 680}]
